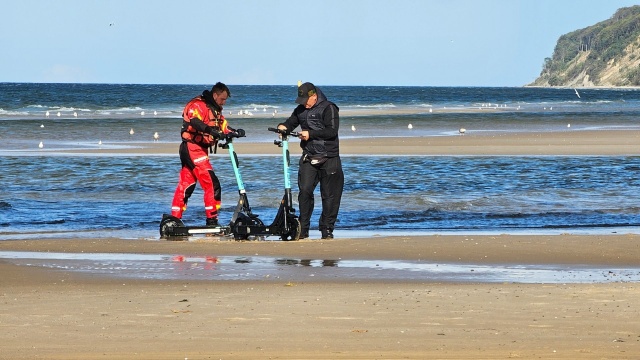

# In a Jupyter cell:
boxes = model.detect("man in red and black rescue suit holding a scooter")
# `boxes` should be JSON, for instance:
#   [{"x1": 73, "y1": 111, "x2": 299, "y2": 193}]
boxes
[{"x1": 171, "y1": 82, "x2": 244, "y2": 227}]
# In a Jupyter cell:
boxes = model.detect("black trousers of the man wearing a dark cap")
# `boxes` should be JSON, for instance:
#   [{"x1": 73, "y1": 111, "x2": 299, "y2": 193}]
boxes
[{"x1": 298, "y1": 156, "x2": 344, "y2": 233}]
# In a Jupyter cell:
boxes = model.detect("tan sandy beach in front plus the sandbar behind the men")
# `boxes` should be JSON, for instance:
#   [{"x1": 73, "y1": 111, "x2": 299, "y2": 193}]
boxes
[{"x1": 0, "y1": 131, "x2": 640, "y2": 359}]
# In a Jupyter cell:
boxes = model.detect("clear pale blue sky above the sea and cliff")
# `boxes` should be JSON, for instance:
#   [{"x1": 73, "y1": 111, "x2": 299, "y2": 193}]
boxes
[{"x1": 0, "y1": 0, "x2": 640, "y2": 86}]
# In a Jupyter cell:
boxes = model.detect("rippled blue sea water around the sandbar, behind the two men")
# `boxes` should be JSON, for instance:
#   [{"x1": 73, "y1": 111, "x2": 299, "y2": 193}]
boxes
[{"x1": 0, "y1": 83, "x2": 640, "y2": 240}]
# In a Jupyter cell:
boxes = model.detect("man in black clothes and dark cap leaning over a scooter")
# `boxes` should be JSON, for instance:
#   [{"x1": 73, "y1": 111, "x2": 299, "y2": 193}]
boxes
[{"x1": 278, "y1": 82, "x2": 344, "y2": 239}]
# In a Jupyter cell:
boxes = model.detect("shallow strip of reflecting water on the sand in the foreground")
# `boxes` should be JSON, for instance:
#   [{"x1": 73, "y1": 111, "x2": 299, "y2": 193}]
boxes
[{"x1": 0, "y1": 251, "x2": 640, "y2": 283}]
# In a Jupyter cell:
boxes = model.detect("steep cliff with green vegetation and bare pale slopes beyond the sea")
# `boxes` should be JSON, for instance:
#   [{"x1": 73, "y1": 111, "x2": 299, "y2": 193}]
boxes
[{"x1": 529, "y1": 5, "x2": 640, "y2": 87}]
